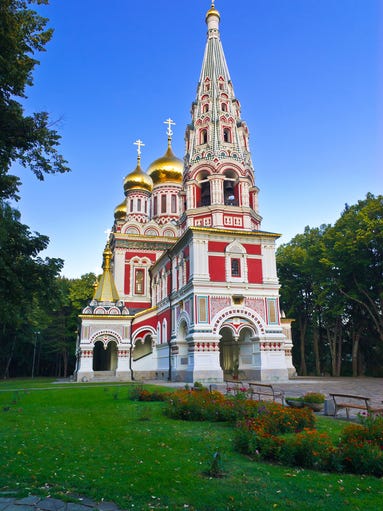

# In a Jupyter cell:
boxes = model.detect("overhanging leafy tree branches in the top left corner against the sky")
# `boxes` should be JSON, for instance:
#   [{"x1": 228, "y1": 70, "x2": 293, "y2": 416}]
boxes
[{"x1": 0, "y1": 0, "x2": 69, "y2": 199}]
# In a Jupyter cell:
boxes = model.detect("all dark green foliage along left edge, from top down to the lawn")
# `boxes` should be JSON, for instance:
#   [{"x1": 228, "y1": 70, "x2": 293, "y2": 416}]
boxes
[{"x1": 0, "y1": 0, "x2": 69, "y2": 377}]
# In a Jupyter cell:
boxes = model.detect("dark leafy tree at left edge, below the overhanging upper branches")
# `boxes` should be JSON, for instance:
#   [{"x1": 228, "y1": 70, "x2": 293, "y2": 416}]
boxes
[{"x1": 0, "y1": 201, "x2": 63, "y2": 376}]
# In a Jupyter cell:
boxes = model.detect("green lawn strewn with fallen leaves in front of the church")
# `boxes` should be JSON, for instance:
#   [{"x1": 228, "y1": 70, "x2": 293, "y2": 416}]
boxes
[{"x1": 0, "y1": 380, "x2": 383, "y2": 511}]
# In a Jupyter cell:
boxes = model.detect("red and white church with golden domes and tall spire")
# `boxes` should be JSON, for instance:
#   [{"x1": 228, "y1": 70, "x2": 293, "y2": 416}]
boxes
[{"x1": 75, "y1": 2, "x2": 295, "y2": 383}]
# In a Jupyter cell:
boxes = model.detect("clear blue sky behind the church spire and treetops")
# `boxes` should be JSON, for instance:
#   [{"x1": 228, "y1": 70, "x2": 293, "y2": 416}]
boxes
[{"x1": 13, "y1": 0, "x2": 383, "y2": 278}]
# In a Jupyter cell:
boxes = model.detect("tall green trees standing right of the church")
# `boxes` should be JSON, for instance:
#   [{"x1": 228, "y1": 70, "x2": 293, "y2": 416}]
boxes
[{"x1": 277, "y1": 194, "x2": 383, "y2": 376}]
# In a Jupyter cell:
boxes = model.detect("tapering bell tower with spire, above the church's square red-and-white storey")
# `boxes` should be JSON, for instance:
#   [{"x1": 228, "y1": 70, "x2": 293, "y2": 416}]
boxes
[{"x1": 181, "y1": 2, "x2": 261, "y2": 231}]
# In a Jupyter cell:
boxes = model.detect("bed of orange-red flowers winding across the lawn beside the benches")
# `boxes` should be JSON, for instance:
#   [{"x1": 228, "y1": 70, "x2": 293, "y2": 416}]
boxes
[{"x1": 162, "y1": 390, "x2": 383, "y2": 477}]
